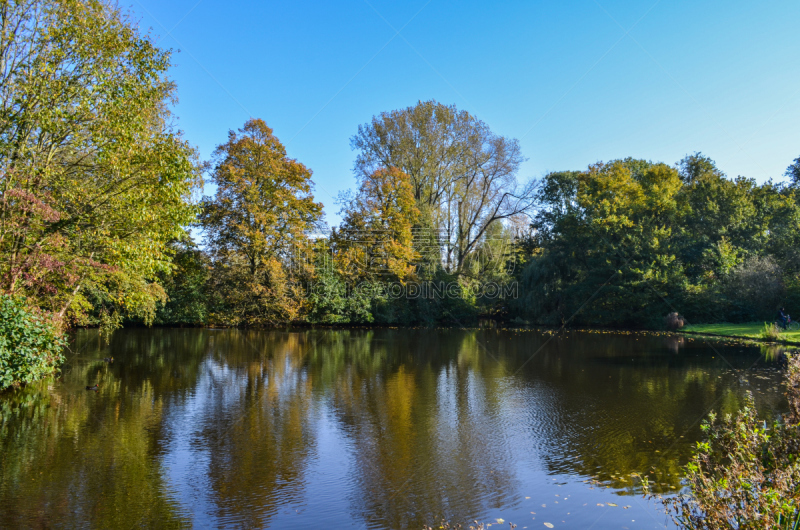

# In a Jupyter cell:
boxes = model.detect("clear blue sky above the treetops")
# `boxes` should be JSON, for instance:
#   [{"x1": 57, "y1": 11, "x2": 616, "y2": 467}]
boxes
[{"x1": 128, "y1": 0, "x2": 800, "y2": 225}]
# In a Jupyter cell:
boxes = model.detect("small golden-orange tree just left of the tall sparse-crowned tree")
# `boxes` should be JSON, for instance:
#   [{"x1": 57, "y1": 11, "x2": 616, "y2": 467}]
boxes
[{"x1": 331, "y1": 167, "x2": 419, "y2": 283}]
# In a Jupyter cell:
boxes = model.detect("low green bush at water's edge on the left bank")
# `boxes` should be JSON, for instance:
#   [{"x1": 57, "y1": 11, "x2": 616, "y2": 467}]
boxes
[{"x1": 0, "y1": 294, "x2": 66, "y2": 390}]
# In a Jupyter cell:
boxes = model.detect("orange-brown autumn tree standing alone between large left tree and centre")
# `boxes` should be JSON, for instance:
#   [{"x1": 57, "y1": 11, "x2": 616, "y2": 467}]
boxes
[{"x1": 200, "y1": 119, "x2": 322, "y2": 324}]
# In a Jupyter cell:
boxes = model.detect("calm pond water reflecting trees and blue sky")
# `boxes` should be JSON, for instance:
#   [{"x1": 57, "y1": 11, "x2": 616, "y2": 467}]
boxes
[{"x1": 0, "y1": 329, "x2": 785, "y2": 529}]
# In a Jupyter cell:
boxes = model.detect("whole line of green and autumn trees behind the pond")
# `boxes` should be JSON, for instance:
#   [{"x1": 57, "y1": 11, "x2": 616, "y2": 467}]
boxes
[{"x1": 0, "y1": 0, "x2": 800, "y2": 388}]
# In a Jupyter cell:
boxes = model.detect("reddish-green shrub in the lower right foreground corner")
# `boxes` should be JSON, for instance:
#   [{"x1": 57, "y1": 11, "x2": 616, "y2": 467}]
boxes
[{"x1": 663, "y1": 356, "x2": 800, "y2": 530}]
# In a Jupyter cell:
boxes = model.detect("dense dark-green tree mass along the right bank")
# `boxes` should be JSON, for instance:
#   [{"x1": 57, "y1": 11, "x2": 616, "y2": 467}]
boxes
[{"x1": 513, "y1": 153, "x2": 800, "y2": 327}]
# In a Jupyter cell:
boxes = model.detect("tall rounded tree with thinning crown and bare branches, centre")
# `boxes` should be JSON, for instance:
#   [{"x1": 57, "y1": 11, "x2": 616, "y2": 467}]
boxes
[{"x1": 351, "y1": 101, "x2": 534, "y2": 273}]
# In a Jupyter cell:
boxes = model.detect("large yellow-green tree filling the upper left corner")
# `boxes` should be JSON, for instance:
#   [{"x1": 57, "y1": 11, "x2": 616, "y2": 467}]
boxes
[{"x1": 0, "y1": 0, "x2": 200, "y2": 330}]
